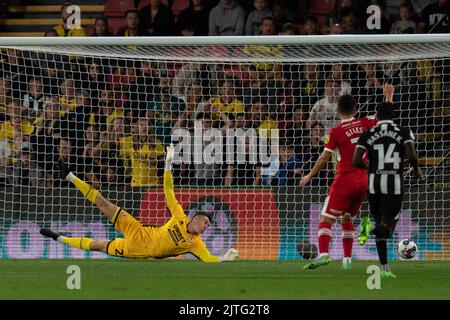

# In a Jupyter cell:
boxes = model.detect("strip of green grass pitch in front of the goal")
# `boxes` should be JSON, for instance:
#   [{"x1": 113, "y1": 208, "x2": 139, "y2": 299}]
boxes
[{"x1": 0, "y1": 260, "x2": 450, "y2": 300}]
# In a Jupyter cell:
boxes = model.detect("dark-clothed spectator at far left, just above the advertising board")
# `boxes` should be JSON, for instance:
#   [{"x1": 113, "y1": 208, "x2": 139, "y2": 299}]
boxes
[{"x1": 11, "y1": 144, "x2": 45, "y2": 188}]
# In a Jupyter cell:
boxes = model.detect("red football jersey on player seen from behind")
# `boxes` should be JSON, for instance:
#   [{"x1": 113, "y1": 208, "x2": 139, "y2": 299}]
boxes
[{"x1": 325, "y1": 116, "x2": 377, "y2": 175}]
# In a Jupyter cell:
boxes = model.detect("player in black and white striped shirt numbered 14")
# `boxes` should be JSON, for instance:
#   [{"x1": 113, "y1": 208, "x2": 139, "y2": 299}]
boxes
[{"x1": 353, "y1": 102, "x2": 422, "y2": 278}]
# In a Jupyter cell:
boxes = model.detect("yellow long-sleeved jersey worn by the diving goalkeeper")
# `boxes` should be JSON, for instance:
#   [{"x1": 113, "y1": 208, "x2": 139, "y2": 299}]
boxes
[{"x1": 147, "y1": 171, "x2": 219, "y2": 262}]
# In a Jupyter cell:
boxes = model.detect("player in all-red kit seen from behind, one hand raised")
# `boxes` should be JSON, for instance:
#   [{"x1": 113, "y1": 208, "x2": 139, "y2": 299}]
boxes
[{"x1": 300, "y1": 86, "x2": 393, "y2": 269}]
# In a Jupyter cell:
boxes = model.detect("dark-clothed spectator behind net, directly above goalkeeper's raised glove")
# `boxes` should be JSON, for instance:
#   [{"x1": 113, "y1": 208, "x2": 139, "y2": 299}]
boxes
[{"x1": 146, "y1": 71, "x2": 185, "y2": 145}]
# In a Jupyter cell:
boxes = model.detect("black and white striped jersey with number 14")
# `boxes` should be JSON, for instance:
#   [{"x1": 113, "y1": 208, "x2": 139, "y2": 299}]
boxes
[{"x1": 356, "y1": 120, "x2": 414, "y2": 194}]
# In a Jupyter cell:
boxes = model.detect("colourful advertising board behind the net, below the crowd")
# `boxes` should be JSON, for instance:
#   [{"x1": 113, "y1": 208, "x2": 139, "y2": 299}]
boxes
[{"x1": 0, "y1": 187, "x2": 450, "y2": 260}]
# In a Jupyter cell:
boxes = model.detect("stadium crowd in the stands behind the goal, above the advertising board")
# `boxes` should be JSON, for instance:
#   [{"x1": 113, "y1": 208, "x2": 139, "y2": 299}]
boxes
[{"x1": 0, "y1": 0, "x2": 449, "y2": 188}]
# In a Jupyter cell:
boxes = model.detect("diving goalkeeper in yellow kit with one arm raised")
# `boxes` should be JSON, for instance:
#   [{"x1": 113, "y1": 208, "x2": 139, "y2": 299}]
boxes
[{"x1": 40, "y1": 144, "x2": 239, "y2": 262}]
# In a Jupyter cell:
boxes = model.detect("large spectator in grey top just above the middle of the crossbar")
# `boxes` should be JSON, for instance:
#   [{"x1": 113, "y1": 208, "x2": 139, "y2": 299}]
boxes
[{"x1": 209, "y1": 0, "x2": 245, "y2": 36}]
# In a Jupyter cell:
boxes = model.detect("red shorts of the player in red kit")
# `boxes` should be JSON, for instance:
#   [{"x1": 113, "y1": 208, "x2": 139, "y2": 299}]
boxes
[{"x1": 321, "y1": 176, "x2": 367, "y2": 220}]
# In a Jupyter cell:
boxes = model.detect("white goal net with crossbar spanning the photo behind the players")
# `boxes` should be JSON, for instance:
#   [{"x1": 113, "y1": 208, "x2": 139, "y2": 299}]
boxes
[{"x1": 0, "y1": 35, "x2": 450, "y2": 260}]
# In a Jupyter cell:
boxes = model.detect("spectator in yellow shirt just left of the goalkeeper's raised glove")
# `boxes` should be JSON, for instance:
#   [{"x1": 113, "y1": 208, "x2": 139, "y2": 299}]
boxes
[{"x1": 120, "y1": 118, "x2": 164, "y2": 187}]
